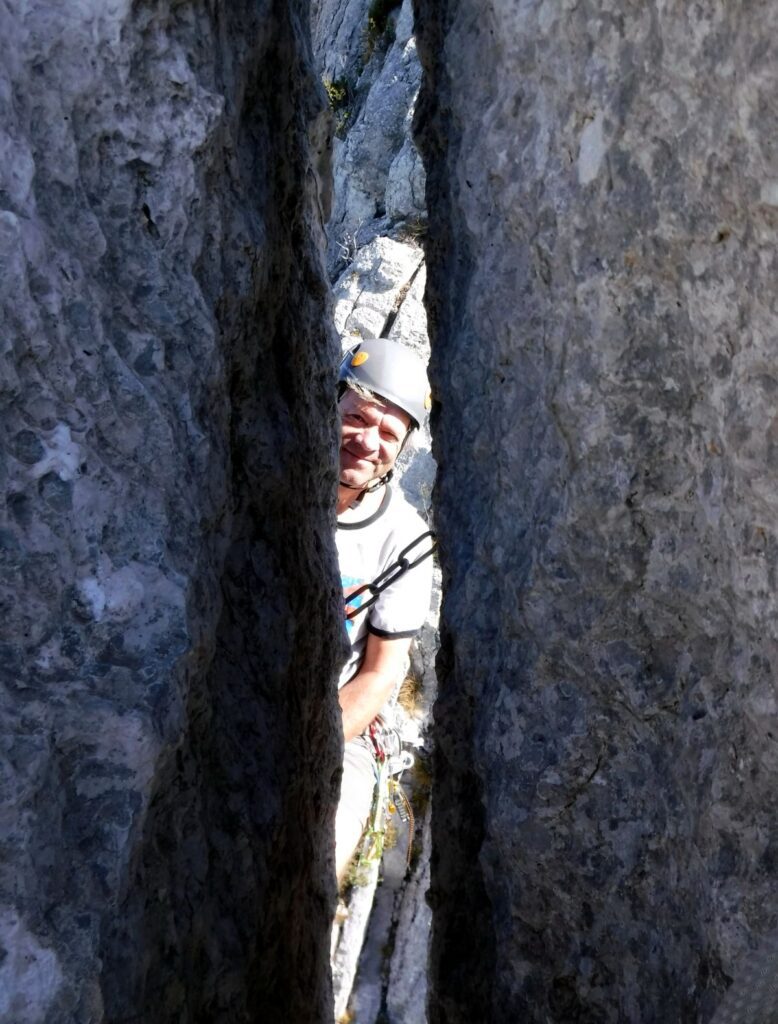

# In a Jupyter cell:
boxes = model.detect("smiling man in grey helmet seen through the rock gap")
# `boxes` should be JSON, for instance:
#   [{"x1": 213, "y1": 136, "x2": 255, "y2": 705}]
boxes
[{"x1": 335, "y1": 339, "x2": 432, "y2": 882}]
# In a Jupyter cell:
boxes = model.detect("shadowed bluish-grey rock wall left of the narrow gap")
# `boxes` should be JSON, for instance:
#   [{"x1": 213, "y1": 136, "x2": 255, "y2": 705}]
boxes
[{"x1": 0, "y1": 0, "x2": 342, "y2": 1024}]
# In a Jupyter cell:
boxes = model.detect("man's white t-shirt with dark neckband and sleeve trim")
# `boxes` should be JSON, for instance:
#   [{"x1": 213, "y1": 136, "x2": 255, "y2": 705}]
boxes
[{"x1": 336, "y1": 484, "x2": 432, "y2": 686}]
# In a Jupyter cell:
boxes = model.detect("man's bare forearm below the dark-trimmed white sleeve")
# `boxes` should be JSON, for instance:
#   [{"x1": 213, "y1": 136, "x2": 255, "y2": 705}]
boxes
[{"x1": 338, "y1": 633, "x2": 410, "y2": 742}]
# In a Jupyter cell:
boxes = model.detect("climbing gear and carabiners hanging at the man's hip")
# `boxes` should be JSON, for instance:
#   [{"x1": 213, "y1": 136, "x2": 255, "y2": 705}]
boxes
[{"x1": 357, "y1": 717, "x2": 416, "y2": 868}]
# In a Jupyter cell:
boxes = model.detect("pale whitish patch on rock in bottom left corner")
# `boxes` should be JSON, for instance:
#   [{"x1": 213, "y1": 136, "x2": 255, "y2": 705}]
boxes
[{"x1": 0, "y1": 907, "x2": 62, "y2": 1024}]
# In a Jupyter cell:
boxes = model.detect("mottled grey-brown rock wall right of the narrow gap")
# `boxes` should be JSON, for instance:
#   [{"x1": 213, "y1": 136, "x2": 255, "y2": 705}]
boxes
[{"x1": 417, "y1": 0, "x2": 778, "y2": 1024}]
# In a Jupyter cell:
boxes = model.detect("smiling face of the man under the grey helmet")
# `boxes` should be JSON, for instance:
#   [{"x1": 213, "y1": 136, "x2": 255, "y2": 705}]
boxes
[{"x1": 340, "y1": 388, "x2": 410, "y2": 490}]
